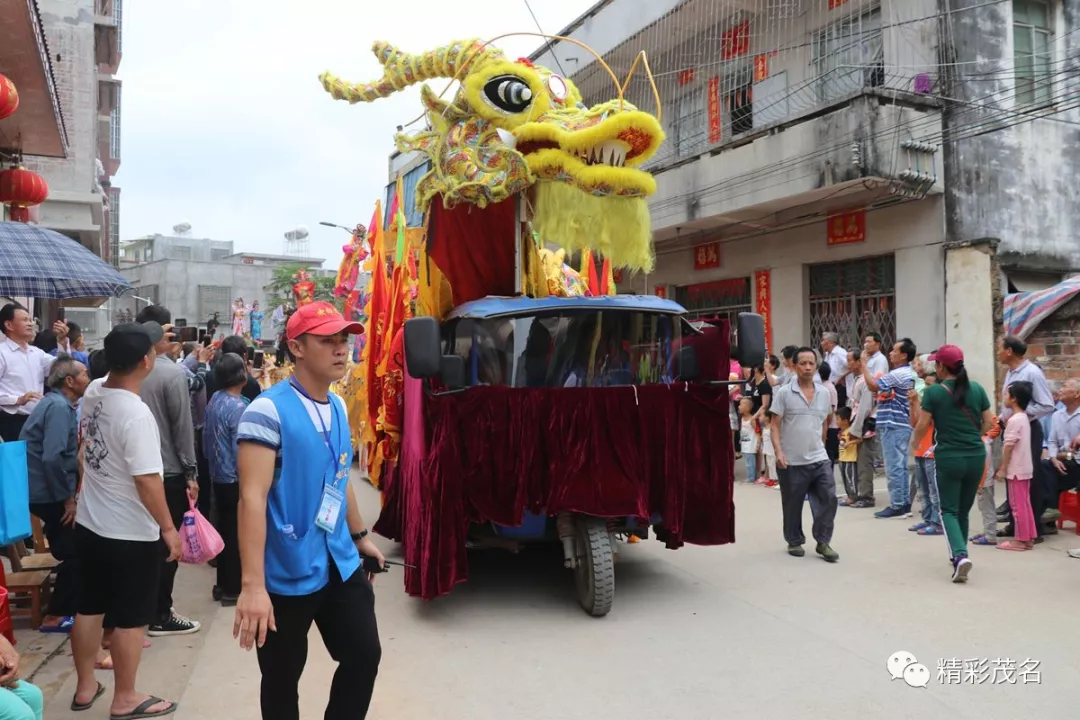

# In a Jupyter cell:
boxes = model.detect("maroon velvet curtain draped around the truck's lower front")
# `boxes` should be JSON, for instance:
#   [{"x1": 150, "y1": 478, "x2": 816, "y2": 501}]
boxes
[{"x1": 375, "y1": 382, "x2": 734, "y2": 599}]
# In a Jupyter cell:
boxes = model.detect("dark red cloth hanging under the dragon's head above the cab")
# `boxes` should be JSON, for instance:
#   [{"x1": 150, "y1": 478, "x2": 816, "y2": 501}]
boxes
[{"x1": 428, "y1": 198, "x2": 515, "y2": 305}]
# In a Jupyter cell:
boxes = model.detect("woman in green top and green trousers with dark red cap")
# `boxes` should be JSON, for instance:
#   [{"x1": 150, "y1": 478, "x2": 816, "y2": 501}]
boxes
[{"x1": 912, "y1": 345, "x2": 994, "y2": 583}]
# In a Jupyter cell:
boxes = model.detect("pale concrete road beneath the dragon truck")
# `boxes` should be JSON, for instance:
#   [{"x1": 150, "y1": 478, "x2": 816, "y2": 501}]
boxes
[{"x1": 37, "y1": 470, "x2": 1080, "y2": 720}]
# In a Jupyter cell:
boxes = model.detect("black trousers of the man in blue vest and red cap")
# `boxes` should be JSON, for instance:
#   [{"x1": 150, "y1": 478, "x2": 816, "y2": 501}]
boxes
[{"x1": 258, "y1": 562, "x2": 382, "y2": 720}]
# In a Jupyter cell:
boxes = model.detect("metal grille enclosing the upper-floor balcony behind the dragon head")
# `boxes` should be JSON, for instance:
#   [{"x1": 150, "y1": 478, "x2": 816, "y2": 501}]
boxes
[{"x1": 541, "y1": 0, "x2": 898, "y2": 172}]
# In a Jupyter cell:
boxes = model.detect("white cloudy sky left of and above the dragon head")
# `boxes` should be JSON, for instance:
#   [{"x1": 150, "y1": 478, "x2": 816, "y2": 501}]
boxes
[{"x1": 114, "y1": 0, "x2": 594, "y2": 267}]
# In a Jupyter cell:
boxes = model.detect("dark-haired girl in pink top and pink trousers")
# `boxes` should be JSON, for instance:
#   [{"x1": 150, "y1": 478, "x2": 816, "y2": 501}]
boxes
[{"x1": 994, "y1": 381, "x2": 1038, "y2": 551}]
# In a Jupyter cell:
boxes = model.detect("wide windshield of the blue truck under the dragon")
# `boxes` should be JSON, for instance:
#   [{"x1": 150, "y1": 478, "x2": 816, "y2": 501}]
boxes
[{"x1": 443, "y1": 310, "x2": 683, "y2": 388}]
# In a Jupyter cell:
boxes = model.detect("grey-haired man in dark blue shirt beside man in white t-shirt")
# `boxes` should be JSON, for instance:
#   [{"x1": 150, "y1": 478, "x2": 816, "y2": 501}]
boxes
[{"x1": 18, "y1": 355, "x2": 90, "y2": 633}]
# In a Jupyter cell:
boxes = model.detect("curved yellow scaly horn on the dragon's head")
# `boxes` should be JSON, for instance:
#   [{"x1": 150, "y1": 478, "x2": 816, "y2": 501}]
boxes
[{"x1": 319, "y1": 40, "x2": 502, "y2": 104}]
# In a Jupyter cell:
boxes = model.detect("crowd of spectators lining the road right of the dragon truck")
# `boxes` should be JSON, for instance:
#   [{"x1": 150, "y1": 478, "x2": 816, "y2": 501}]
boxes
[{"x1": 731, "y1": 332, "x2": 1080, "y2": 582}]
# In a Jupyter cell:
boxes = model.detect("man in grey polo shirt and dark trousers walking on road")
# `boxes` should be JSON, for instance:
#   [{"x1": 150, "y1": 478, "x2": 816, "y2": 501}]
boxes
[{"x1": 769, "y1": 348, "x2": 840, "y2": 562}]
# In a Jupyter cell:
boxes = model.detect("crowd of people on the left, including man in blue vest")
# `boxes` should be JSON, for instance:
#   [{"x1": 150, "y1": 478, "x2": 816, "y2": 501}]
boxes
[{"x1": 0, "y1": 302, "x2": 384, "y2": 720}]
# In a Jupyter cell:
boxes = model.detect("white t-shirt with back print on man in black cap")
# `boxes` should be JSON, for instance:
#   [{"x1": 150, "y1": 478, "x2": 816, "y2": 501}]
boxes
[{"x1": 76, "y1": 380, "x2": 163, "y2": 542}]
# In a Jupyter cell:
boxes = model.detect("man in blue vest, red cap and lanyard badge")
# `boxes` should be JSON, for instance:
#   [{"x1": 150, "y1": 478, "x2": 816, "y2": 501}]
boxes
[{"x1": 232, "y1": 302, "x2": 384, "y2": 720}]
